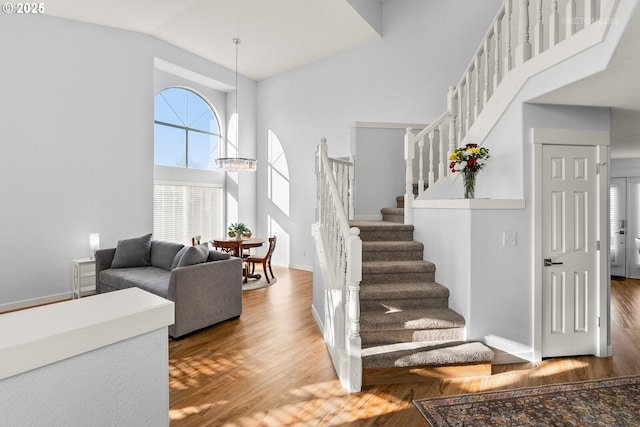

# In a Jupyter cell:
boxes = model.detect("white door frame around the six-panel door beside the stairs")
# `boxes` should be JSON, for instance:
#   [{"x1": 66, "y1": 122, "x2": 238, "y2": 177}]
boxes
[{"x1": 531, "y1": 128, "x2": 612, "y2": 361}]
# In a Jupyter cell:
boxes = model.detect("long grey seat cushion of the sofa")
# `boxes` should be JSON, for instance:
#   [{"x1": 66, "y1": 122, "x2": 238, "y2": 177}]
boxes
[{"x1": 100, "y1": 266, "x2": 171, "y2": 298}]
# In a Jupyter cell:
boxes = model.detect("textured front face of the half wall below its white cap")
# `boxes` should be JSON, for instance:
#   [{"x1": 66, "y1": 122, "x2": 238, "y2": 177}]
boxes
[{"x1": 0, "y1": 327, "x2": 169, "y2": 427}]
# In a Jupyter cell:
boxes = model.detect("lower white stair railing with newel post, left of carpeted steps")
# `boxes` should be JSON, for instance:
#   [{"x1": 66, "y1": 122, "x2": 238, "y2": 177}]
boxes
[{"x1": 312, "y1": 138, "x2": 362, "y2": 392}]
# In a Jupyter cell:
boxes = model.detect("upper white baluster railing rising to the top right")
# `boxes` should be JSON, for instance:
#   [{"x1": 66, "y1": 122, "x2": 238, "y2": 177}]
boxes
[{"x1": 405, "y1": 0, "x2": 616, "y2": 224}]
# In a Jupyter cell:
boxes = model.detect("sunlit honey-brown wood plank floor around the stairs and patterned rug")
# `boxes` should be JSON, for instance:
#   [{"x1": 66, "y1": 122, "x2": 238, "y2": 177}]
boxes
[{"x1": 169, "y1": 268, "x2": 640, "y2": 427}]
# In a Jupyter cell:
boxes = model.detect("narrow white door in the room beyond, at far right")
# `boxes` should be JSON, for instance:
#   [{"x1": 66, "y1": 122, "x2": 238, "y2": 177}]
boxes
[{"x1": 609, "y1": 178, "x2": 627, "y2": 277}]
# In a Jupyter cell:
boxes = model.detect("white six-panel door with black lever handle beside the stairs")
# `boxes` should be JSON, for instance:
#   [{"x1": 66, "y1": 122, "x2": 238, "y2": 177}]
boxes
[{"x1": 542, "y1": 145, "x2": 598, "y2": 357}]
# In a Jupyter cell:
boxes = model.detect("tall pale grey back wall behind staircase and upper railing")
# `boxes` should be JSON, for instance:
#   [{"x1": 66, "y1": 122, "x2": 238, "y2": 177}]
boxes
[{"x1": 257, "y1": 0, "x2": 502, "y2": 269}]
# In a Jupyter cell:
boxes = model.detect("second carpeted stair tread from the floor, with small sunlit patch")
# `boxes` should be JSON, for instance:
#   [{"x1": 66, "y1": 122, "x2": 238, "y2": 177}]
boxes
[{"x1": 360, "y1": 308, "x2": 465, "y2": 332}]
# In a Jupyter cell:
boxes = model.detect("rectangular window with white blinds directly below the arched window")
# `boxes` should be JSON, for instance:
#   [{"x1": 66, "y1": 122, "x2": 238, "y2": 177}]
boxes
[{"x1": 153, "y1": 182, "x2": 224, "y2": 244}]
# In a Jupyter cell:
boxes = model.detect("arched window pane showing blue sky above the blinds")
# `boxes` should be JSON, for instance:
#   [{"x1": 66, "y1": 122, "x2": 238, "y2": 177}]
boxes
[{"x1": 154, "y1": 87, "x2": 222, "y2": 170}]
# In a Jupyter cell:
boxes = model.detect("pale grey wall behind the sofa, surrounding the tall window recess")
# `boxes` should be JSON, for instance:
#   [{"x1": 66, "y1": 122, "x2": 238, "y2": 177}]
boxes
[{"x1": 0, "y1": 15, "x2": 256, "y2": 311}]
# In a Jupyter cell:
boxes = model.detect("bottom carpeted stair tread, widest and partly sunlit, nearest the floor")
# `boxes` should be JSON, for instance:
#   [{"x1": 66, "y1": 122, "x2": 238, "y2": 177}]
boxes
[{"x1": 362, "y1": 341, "x2": 494, "y2": 368}]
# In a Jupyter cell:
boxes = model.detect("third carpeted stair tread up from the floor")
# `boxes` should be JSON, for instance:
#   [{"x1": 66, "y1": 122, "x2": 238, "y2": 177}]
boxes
[{"x1": 360, "y1": 282, "x2": 449, "y2": 303}]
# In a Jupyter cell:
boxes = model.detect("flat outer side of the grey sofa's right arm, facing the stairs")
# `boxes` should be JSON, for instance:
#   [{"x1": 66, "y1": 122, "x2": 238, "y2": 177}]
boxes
[{"x1": 167, "y1": 257, "x2": 242, "y2": 338}]
